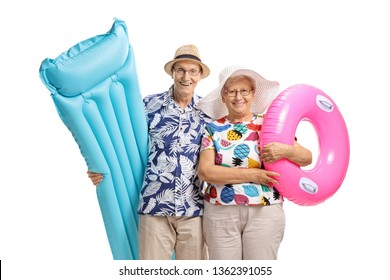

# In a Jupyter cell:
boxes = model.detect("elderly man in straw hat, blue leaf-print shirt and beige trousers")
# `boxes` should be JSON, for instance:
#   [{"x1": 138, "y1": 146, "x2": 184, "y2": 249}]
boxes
[{"x1": 88, "y1": 45, "x2": 211, "y2": 260}]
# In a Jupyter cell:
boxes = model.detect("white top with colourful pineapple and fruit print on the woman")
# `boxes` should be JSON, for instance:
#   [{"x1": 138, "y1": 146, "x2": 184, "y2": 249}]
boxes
[{"x1": 201, "y1": 115, "x2": 283, "y2": 205}]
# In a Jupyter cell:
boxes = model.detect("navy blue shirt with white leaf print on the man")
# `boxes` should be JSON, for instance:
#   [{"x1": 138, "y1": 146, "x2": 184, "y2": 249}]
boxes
[{"x1": 138, "y1": 86, "x2": 211, "y2": 216}]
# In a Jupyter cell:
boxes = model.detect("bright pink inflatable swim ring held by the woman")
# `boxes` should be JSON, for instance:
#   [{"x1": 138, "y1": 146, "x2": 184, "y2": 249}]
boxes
[{"x1": 260, "y1": 84, "x2": 350, "y2": 206}]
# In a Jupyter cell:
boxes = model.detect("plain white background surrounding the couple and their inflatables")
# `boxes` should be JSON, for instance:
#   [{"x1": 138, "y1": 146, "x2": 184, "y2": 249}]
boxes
[{"x1": 0, "y1": 0, "x2": 390, "y2": 279}]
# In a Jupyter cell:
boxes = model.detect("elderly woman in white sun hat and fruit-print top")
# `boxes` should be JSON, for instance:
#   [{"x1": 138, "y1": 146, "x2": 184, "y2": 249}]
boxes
[{"x1": 198, "y1": 66, "x2": 312, "y2": 260}]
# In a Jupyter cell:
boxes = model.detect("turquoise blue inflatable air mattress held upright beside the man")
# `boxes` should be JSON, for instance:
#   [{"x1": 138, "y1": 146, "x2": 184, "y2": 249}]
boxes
[{"x1": 39, "y1": 19, "x2": 148, "y2": 260}]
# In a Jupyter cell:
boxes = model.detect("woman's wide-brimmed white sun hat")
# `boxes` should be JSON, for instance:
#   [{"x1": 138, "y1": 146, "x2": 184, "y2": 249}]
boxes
[{"x1": 197, "y1": 65, "x2": 279, "y2": 120}]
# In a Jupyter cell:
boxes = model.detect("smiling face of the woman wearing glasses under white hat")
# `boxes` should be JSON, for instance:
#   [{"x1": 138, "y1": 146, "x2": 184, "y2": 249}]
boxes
[{"x1": 222, "y1": 79, "x2": 254, "y2": 117}]
